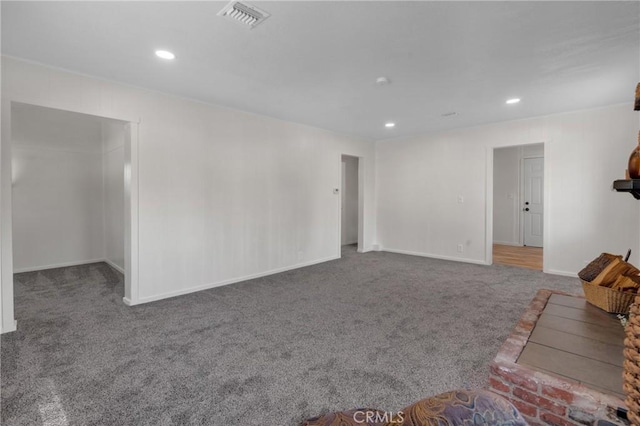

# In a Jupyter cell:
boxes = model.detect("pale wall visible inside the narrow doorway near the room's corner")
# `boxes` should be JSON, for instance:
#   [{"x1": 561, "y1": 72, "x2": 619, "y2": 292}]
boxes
[{"x1": 341, "y1": 156, "x2": 358, "y2": 245}]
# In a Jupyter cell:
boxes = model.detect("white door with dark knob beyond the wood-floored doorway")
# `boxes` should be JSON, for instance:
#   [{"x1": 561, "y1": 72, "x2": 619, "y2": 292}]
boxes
[{"x1": 522, "y1": 158, "x2": 544, "y2": 247}]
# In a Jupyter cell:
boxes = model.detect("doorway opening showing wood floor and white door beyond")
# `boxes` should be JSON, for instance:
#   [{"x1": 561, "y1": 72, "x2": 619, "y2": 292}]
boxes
[{"x1": 492, "y1": 143, "x2": 544, "y2": 271}]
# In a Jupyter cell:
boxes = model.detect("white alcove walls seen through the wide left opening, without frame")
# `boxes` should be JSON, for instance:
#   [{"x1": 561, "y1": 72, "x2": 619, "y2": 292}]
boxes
[{"x1": 11, "y1": 104, "x2": 126, "y2": 288}]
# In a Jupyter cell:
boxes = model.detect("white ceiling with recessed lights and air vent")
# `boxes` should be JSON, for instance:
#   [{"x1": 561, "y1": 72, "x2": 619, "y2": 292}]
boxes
[{"x1": 2, "y1": 1, "x2": 640, "y2": 139}]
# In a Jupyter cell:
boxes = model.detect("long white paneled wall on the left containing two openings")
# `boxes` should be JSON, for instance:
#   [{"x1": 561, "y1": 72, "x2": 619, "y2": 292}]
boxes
[{"x1": 2, "y1": 57, "x2": 375, "y2": 324}]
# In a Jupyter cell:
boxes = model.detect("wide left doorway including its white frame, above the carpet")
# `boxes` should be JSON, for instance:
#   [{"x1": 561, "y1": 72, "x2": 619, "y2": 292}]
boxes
[{"x1": 1, "y1": 101, "x2": 138, "y2": 332}]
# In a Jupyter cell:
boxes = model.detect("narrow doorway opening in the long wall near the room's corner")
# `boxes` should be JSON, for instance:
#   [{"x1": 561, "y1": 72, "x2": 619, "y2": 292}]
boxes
[{"x1": 340, "y1": 155, "x2": 360, "y2": 255}]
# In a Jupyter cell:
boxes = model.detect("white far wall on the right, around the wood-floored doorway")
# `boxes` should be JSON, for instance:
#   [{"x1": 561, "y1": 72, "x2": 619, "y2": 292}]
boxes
[{"x1": 376, "y1": 105, "x2": 640, "y2": 274}]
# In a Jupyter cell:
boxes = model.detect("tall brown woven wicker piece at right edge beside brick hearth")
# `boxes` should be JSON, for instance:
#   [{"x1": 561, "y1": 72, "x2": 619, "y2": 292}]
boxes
[{"x1": 622, "y1": 297, "x2": 640, "y2": 425}]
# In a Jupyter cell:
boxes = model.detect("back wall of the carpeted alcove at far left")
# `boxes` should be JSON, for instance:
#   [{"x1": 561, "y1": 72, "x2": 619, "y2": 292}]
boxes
[{"x1": 12, "y1": 105, "x2": 104, "y2": 272}]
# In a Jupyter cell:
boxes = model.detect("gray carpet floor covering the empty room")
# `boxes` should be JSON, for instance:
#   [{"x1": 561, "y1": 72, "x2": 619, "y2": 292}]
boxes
[{"x1": 1, "y1": 247, "x2": 581, "y2": 426}]
